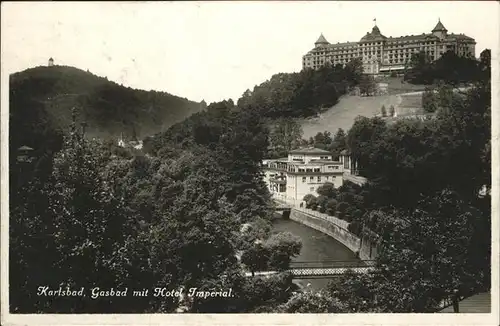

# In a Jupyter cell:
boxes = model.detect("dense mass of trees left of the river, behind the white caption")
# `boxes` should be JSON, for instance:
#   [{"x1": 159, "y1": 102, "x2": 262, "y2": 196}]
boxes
[{"x1": 10, "y1": 102, "x2": 301, "y2": 312}]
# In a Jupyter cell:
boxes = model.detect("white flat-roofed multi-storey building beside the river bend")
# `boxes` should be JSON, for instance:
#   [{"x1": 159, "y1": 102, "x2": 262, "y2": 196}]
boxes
[{"x1": 263, "y1": 148, "x2": 356, "y2": 203}]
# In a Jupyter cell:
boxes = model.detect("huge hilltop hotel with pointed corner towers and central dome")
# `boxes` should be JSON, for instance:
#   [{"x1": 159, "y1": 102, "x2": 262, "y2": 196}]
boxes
[{"x1": 302, "y1": 21, "x2": 476, "y2": 74}]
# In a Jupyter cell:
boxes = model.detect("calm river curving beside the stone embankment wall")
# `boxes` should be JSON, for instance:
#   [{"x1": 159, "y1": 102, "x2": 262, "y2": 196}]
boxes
[{"x1": 273, "y1": 219, "x2": 358, "y2": 290}]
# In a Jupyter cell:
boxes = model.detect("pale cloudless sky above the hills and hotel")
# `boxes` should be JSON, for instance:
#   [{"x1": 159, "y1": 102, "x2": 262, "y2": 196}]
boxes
[{"x1": 1, "y1": 1, "x2": 500, "y2": 103}]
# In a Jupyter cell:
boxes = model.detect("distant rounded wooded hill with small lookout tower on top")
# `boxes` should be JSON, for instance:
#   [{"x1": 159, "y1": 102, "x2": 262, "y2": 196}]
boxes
[{"x1": 9, "y1": 66, "x2": 201, "y2": 145}]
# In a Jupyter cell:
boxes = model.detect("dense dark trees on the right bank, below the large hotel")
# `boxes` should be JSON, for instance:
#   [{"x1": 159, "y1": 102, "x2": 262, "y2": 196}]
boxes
[{"x1": 284, "y1": 51, "x2": 491, "y2": 312}]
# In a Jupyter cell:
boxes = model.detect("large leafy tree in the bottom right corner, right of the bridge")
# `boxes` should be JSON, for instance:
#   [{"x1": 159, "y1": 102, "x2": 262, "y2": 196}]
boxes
[{"x1": 367, "y1": 190, "x2": 489, "y2": 312}]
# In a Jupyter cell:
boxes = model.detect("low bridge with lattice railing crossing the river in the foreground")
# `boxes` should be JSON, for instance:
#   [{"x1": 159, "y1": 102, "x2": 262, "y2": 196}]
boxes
[{"x1": 245, "y1": 260, "x2": 375, "y2": 279}]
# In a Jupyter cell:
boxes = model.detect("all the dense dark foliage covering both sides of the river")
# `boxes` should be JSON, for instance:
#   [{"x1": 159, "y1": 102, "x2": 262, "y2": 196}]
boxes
[{"x1": 9, "y1": 47, "x2": 491, "y2": 313}]
